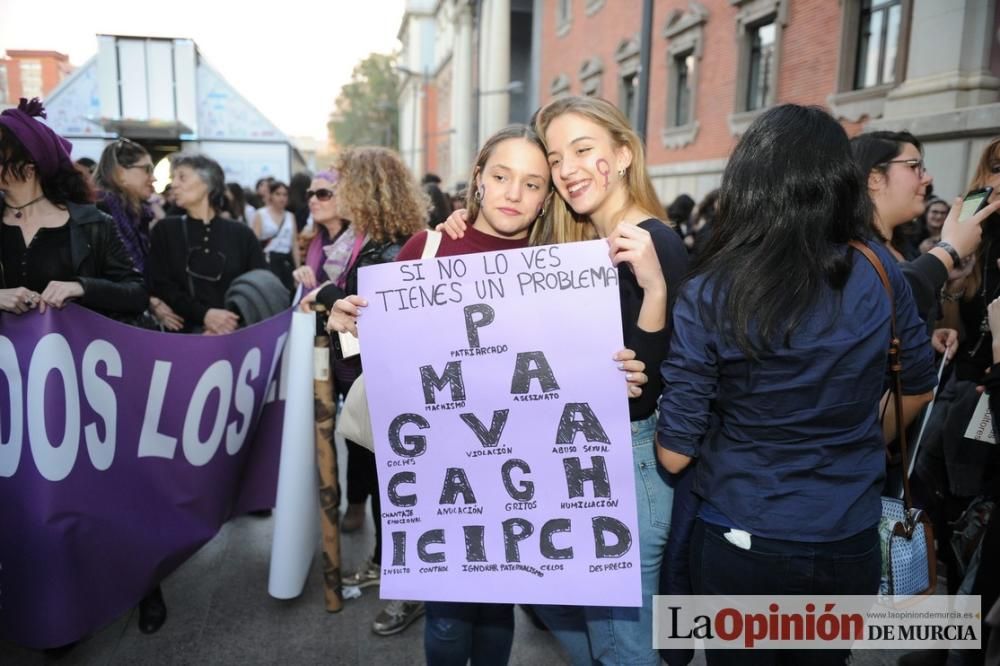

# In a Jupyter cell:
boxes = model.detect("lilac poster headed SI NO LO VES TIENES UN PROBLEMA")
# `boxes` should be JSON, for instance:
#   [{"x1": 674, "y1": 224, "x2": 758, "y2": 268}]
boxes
[{"x1": 358, "y1": 241, "x2": 641, "y2": 606}]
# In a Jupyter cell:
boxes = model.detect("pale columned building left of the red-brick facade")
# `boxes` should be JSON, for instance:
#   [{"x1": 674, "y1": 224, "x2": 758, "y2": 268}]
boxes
[{"x1": 398, "y1": 0, "x2": 540, "y2": 189}]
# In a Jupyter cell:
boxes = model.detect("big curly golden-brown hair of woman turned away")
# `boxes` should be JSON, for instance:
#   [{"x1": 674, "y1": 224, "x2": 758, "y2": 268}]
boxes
[{"x1": 336, "y1": 146, "x2": 431, "y2": 243}]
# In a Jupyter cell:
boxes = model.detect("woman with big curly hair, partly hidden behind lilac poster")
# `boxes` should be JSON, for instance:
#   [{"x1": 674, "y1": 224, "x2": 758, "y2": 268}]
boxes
[{"x1": 303, "y1": 147, "x2": 430, "y2": 576}]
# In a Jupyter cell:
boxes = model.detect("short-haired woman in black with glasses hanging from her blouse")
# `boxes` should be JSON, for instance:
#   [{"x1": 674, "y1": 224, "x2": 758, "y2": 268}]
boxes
[{"x1": 147, "y1": 155, "x2": 267, "y2": 335}]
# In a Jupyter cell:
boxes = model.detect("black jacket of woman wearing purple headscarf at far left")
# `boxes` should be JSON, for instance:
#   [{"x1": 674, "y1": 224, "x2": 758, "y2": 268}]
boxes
[{"x1": 0, "y1": 203, "x2": 149, "y2": 315}]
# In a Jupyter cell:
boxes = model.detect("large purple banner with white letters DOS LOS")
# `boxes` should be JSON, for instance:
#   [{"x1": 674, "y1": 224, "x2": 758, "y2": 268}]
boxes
[{"x1": 0, "y1": 306, "x2": 291, "y2": 648}]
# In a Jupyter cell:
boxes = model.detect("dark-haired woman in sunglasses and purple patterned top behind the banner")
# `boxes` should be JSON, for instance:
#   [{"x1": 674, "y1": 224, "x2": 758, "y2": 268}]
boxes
[{"x1": 94, "y1": 139, "x2": 184, "y2": 331}]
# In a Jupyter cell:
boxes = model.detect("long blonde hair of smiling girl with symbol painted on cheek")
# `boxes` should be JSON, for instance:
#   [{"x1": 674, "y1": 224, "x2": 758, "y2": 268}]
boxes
[{"x1": 532, "y1": 96, "x2": 670, "y2": 243}]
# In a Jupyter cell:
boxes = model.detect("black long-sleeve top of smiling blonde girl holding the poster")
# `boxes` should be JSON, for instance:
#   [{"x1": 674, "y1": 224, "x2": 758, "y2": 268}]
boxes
[{"x1": 618, "y1": 218, "x2": 688, "y2": 421}]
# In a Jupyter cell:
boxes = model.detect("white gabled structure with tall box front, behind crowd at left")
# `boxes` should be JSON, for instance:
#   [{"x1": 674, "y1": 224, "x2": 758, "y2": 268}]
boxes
[{"x1": 45, "y1": 35, "x2": 305, "y2": 186}]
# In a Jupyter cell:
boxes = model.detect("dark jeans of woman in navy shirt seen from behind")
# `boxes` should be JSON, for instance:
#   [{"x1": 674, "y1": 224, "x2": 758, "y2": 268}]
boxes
[{"x1": 691, "y1": 518, "x2": 882, "y2": 666}]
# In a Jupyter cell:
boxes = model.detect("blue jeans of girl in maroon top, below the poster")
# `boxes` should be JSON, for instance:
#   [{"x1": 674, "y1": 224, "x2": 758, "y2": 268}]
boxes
[{"x1": 424, "y1": 601, "x2": 514, "y2": 666}]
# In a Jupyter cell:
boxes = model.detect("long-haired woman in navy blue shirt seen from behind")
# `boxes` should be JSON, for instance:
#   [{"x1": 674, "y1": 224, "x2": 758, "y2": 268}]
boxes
[{"x1": 657, "y1": 104, "x2": 935, "y2": 664}]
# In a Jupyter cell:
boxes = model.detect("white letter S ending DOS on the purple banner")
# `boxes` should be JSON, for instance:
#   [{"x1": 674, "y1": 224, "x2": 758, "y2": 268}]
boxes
[{"x1": 80, "y1": 340, "x2": 122, "y2": 472}]
